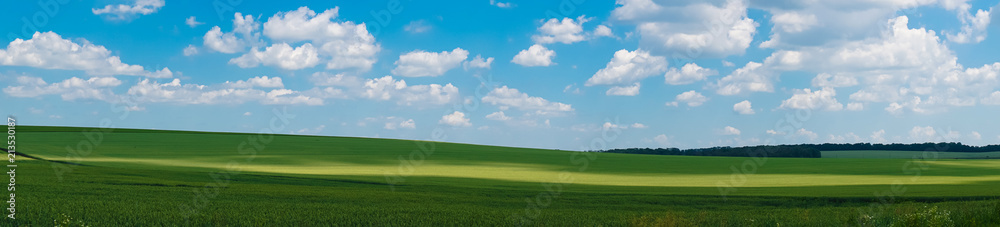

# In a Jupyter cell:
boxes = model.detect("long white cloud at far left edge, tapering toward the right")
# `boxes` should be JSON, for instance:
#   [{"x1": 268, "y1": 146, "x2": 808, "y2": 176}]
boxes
[{"x1": 0, "y1": 32, "x2": 173, "y2": 78}]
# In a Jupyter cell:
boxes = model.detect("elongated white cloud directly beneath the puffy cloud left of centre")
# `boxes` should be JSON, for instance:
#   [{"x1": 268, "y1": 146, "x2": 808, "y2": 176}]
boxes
[{"x1": 362, "y1": 76, "x2": 459, "y2": 106}]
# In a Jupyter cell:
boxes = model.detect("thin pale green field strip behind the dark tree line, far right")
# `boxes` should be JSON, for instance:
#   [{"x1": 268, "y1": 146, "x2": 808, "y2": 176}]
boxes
[{"x1": 823, "y1": 151, "x2": 1000, "y2": 159}]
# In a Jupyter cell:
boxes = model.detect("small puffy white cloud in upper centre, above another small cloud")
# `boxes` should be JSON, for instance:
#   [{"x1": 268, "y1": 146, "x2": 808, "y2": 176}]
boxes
[{"x1": 531, "y1": 16, "x2": 590, "y2": 44}]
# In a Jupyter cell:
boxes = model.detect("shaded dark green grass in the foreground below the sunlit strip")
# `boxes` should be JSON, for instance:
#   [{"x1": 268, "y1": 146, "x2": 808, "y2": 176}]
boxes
[{"x1": 11, "y1": 161, "x2": 1000, "y2": 226}]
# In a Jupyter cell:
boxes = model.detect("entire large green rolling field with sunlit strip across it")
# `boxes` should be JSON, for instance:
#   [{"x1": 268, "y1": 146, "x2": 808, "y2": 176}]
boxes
[{"x1": 7, "y1": 127, "x2": 1000, "y2": 226}]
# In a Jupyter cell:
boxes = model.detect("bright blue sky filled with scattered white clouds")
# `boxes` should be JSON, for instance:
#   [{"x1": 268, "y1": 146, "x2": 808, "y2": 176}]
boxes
[{"x1": 0, "y1": 0, "x2": 1000, "y2": 150}]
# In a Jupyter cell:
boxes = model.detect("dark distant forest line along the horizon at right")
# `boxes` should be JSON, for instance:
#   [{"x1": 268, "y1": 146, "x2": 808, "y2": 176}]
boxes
[{"x1": 596, "y1": 143, "x2": 1000, "y2": 158}]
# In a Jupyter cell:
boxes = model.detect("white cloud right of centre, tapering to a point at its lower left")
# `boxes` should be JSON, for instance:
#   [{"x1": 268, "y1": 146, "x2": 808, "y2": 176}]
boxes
[{"x1": 584, "y1": 49, "x2": 667, "y2": 86}]
